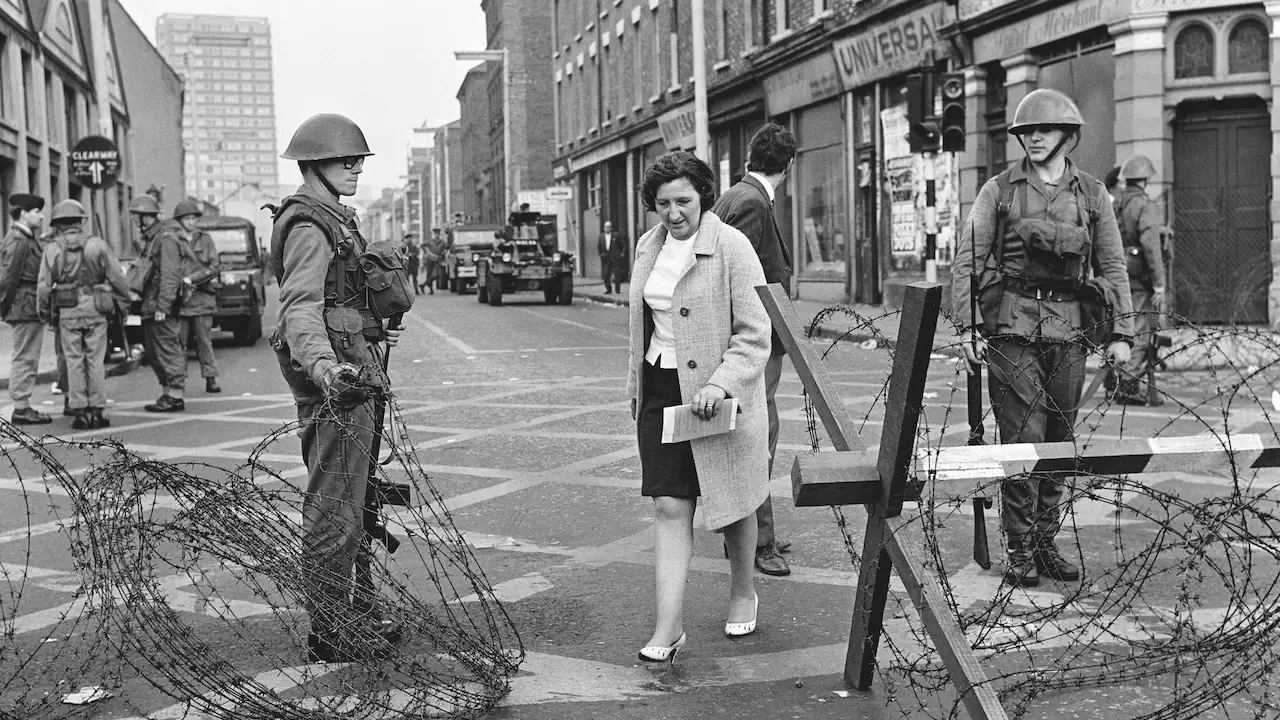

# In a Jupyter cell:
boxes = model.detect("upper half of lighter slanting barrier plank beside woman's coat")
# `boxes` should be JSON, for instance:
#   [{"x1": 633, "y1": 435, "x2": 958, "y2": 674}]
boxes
[{"x1": 755, "y1": 283, "x2": 867, "y2": 451}]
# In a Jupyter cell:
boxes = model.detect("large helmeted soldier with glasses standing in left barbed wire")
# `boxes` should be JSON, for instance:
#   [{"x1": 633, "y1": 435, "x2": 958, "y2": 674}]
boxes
[{"x1": 271, "y1": 114, "x2": 399, "y2": 661}]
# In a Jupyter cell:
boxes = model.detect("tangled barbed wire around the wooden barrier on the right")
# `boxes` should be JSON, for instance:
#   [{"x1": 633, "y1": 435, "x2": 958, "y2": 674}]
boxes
[{"x1": 805, "y1": 305, "x2": 1280, "y2": 720}]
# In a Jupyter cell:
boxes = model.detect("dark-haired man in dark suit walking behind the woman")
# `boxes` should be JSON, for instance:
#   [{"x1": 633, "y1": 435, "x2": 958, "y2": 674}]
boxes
[{"x1": 712, "y1": 123, "x2": 797, "y2": 575}]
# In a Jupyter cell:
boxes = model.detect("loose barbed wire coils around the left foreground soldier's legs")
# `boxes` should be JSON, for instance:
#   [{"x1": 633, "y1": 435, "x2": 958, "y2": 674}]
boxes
[{"x1": 0, "y1": 386, "x2": 524, "y2": 720}]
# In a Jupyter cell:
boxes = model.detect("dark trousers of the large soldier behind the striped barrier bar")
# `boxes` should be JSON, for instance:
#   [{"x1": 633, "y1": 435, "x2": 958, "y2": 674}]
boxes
[{"x1": 988, "y1": 337, "x2": 1085, "y2": 542}]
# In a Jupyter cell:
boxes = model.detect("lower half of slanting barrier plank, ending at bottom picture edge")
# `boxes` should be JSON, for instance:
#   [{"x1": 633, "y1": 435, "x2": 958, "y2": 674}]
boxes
[{"x1": 884, "y1": 516, "x2": 1007, "y2": 720}]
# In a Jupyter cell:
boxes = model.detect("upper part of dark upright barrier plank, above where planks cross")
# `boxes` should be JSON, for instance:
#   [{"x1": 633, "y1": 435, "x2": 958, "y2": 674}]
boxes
[{"x1": 878, "y1": 282, "x2": 942, "y2": 518}]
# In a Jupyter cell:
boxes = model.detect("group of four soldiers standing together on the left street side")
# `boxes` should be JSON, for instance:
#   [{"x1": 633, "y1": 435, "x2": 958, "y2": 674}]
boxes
[{"x1": 0, "y1": 193, "x2": 221, "y2": 429}]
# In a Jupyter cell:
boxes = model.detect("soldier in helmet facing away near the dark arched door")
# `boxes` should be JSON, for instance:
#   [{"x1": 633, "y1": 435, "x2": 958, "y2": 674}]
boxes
[{"x1": 1112, "y1": 155, "x2": 1167, "y2": 405}]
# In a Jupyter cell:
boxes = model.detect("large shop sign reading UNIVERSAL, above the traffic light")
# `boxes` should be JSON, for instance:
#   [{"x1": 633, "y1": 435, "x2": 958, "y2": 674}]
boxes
[{"x1": 832, "y1": 3, "x2": 950, "y2": 90}]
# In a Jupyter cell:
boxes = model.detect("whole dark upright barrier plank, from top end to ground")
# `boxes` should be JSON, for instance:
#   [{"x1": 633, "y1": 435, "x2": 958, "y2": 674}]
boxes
[{"x1": 845, "y1": 283, "x2": 942, "y2": 689}]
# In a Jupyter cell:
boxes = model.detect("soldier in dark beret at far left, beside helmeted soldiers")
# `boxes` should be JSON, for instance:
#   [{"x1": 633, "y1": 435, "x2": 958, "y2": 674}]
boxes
[{"x1": 0, "y1": 193, "x2": 52, "y2": 425}]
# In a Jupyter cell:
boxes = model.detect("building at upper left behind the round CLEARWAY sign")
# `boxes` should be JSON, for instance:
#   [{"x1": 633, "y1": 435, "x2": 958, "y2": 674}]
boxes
[{"x1": 0, "y1": 0, "x2": 182, "y2": 252}]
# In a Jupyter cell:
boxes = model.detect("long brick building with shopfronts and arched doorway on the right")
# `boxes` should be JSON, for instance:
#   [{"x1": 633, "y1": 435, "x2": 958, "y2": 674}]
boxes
[{"x1": 552, "y1": 0, "x2": 1280, "y2": 325}]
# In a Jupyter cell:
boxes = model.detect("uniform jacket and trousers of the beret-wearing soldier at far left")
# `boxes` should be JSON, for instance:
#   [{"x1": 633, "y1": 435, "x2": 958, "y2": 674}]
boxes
[{"x1": 0, "y1": 199, "x2": 49, "y2": 424}]
